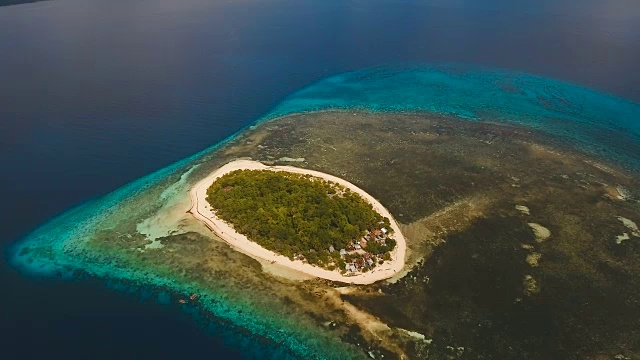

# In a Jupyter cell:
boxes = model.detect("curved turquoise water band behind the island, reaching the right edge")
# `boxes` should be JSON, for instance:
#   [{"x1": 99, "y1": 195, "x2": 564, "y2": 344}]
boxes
[{"x1": 265, "y1": 65, "x2": 640, "y2": 170}]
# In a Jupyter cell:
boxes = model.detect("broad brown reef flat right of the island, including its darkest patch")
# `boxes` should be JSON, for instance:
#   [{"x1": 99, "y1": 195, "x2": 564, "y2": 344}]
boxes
[{"x1": 241, "y1": 112, "x2": 640, "y2": 359}]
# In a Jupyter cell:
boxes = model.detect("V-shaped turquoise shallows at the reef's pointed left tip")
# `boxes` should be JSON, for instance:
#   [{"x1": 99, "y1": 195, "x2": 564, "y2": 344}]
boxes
[{"x1": 11, "y1": 121, "x2": 361, "y2": 359}]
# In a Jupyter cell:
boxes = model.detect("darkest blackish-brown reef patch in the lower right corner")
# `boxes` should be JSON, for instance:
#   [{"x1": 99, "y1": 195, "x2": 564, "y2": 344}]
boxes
[{"x1": 345, "y1": 216, "x2": 640, "y2": 359}]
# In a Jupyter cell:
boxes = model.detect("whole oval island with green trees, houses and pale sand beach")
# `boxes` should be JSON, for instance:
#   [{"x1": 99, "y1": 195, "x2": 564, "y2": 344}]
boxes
[{"x1": 190, "y1": 160, "x2": 405, "y2": 284}]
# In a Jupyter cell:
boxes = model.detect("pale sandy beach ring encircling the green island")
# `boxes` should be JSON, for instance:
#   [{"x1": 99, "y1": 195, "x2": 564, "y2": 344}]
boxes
[{"x1": 189, "y1": 160, "x2": 406, "y2": 284}]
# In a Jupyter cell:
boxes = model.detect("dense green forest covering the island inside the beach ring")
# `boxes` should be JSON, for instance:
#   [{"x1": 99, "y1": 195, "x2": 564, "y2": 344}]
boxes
[{"x1": 207, "y1": 170, "x2": 395, "y2": 268}]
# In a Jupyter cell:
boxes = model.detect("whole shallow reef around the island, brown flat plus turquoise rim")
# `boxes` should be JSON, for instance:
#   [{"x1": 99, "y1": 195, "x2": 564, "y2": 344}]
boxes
[{"x1": 12, "y1": 66, "x2": 640, "y2": 359}]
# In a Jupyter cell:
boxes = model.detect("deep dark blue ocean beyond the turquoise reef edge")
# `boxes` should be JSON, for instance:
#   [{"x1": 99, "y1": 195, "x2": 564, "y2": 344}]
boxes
[{"x1": 0, "y1": 0, "x2": 640, "y2": 359}]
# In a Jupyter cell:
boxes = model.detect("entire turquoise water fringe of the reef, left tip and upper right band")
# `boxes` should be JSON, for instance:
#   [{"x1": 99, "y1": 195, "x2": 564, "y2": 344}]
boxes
[{"x1": 12, "y1": 65, "x2": 640, "y2": 358}]
